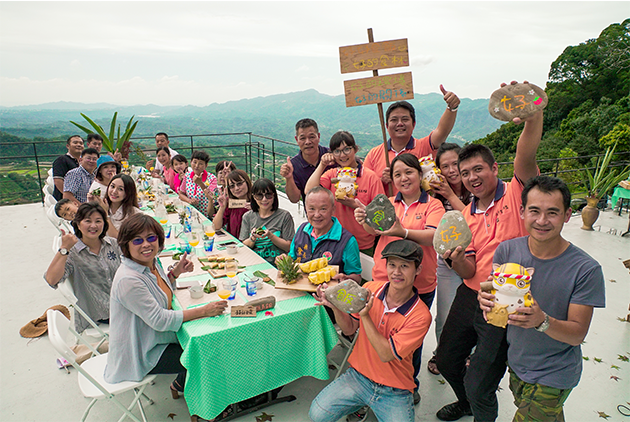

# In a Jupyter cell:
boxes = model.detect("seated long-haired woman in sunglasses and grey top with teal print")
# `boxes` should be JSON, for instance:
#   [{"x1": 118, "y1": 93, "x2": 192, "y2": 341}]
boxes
[{"x1": 239, "y1": 179, "x2": 295, "y2": 265}]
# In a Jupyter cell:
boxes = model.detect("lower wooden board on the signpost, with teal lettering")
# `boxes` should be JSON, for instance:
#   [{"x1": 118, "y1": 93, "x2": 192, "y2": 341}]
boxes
[{"x1": 343, "y1": 72, "x2": 413, "y2": 107}]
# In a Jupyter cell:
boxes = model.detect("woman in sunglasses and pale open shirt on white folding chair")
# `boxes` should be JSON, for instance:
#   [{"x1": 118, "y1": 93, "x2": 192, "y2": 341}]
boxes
[{"x1": 105, "y1": 214, "x2": 227, "y2": 408}]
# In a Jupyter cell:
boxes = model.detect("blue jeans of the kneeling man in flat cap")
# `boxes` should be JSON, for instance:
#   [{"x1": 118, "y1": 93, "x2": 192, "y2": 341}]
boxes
[{"x1": 308, "y1": 367, "x2": 415, "y2": 422}]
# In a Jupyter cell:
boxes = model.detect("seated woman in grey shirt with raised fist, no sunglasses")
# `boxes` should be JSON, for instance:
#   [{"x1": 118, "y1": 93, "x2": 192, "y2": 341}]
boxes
[{"x1": 44, "y1": 202, "x2": 121, "y2": 333}]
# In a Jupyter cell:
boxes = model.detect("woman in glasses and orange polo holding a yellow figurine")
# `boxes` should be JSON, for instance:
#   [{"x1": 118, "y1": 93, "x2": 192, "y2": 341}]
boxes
[{"x1": 304, "y1": 130, "x2": 385, "y2": 256}]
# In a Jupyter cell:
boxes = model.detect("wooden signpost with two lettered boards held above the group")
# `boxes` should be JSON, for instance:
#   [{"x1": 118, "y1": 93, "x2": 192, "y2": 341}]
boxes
[{"x1": 339, "y1": 28, "x2": 413, "y2": 195}]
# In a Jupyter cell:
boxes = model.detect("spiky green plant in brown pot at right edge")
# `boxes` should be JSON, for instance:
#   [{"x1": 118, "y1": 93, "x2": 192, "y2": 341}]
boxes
[{"x1": 582, "y1": 142, "x2": 630, "y2": 230}]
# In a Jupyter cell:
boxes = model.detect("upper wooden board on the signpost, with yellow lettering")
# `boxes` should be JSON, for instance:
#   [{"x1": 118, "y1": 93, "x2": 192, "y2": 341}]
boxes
[{"x1": 339, "y1": 38, "x2": 409, "y2": 73}]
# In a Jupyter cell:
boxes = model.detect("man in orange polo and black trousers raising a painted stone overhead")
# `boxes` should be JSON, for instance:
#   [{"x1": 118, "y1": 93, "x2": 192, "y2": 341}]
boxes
[{"x1": 436, "y1": 99, "x2": 543, "y2": 422}]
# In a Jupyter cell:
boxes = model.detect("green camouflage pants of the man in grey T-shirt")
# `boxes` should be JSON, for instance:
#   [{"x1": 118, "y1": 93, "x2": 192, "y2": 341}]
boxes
[{"x1": 510, "y1": 369, "x2": 572, "y2": 422}]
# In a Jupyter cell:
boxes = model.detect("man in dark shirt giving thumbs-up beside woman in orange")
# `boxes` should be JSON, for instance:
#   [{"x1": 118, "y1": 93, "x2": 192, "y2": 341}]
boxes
[{"x1": 280, "y1": 119, "x2": 330, "y2": 204}]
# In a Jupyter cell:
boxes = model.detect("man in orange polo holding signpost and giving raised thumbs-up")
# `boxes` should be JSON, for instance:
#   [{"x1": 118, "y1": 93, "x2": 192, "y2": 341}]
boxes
[{"x1": 363, "y1": 85, "x2": 460, "y2": 196}]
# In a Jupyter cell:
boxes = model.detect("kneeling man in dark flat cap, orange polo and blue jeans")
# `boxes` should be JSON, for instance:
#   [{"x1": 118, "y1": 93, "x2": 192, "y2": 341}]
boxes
[{"x1": 309, "y1": 239, "x2": 431, "y2": 422}]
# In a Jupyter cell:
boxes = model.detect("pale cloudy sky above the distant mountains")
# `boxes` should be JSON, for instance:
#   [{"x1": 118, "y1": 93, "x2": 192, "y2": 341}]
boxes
[{"x1": 0, "y1": 1, "x2": 630, "y2": 107}]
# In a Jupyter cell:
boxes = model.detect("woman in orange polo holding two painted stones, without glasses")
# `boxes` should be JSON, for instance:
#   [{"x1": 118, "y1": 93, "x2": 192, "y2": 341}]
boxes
[{"x1": 354, "y1": 153, "x2": 444, "y2": 403}]
